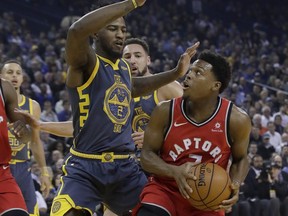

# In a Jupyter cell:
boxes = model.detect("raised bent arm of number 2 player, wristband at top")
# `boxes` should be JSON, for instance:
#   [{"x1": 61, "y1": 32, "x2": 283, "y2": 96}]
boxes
[{"x1": 65, "y1": 0, "x2": 145, "y2": 87}]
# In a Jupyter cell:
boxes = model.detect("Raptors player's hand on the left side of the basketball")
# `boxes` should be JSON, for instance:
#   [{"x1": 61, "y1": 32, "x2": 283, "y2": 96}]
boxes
[{"x1": 173, "y1": 162, "x2": 197, "y2": 199}]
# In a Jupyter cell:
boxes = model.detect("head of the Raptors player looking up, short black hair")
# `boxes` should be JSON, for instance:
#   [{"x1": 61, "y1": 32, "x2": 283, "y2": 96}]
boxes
[{"x1": 183, "y1": 51, "x2": 231, "y2": 98}]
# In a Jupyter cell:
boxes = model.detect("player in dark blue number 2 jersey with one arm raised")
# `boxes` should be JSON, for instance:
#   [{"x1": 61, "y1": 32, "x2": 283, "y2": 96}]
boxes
[{"x1": 44, "y1": 0, "x2": 199, "y2": 216}]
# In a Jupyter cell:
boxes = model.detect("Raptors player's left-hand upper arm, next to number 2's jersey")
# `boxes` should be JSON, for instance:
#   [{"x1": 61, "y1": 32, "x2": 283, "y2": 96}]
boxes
[{"x1": 143, "y1": 102, "x2": 169, "y2": 153}]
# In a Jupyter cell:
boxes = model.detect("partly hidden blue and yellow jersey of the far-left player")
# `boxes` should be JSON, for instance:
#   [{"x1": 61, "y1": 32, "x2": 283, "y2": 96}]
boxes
[{"x1": 8, "y1": 95, "x2": 33, "y2": 161}]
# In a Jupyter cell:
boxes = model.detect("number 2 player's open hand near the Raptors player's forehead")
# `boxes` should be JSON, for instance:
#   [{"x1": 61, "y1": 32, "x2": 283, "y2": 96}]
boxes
[{"x1": 176, "y1": 42, "x2": 200, "y2": 77}]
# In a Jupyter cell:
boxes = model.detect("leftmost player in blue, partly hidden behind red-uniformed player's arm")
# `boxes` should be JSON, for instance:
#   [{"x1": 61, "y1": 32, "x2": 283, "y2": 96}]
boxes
[{"x1": 1, "y1": 60, "x2": 50, "y2": 216}]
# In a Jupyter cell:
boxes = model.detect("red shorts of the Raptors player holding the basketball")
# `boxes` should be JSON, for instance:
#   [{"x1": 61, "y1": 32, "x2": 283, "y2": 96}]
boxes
[{"x1": 133, "y1": 178, "x2": 225, "y2": 216}]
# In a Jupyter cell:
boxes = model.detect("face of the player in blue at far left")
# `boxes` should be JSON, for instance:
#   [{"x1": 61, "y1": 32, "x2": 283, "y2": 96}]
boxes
[{"x1": 2, "y1": 63, "x2": 23, "y2": 89}]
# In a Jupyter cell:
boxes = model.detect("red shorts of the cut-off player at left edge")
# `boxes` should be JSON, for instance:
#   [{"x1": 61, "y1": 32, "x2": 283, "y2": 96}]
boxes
[{"x1": 0, "y1": 164, "x2": 27, "y2": 215}]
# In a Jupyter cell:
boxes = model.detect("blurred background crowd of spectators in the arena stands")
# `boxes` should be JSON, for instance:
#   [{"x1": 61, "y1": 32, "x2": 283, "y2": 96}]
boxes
[{"x1": 0, "y1": 0, "x2": 288, "y2": 215}]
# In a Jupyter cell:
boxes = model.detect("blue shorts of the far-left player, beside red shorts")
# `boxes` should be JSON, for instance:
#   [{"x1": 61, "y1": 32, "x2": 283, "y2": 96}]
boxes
[{"x1": 10, "y1": 161, "x2": 39, "y2": 215}]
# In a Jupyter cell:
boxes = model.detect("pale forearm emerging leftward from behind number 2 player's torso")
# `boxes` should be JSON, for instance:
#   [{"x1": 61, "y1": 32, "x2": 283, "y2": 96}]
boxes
[{"x1": 40, "y1": 121, "x2": 73, "y2": 137}]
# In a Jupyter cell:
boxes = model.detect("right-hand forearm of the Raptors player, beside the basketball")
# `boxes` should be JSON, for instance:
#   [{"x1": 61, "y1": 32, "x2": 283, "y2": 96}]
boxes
[{"x1": 230, "y1": 157, "x2": 249, "y2": 186}]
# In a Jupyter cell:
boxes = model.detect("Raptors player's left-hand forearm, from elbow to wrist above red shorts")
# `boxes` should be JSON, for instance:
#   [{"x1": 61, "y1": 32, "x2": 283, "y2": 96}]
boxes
[{"x1": 140, "y1": 149, "x2": 176, "y2": 178}]
